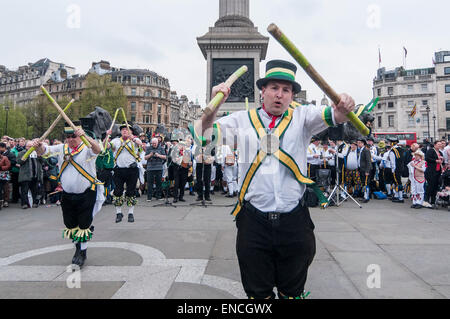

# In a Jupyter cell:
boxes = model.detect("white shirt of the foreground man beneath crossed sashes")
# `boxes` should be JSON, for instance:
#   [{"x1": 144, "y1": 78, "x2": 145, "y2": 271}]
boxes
[{"x1": 217, "y1": 105, "x2": 334, "y2": 212}]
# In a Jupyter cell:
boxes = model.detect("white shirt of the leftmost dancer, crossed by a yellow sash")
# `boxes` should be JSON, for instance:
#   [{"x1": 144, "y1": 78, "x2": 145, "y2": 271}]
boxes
[{"x1": 44, "y1": 144, "x2": 97, "y2": 194}]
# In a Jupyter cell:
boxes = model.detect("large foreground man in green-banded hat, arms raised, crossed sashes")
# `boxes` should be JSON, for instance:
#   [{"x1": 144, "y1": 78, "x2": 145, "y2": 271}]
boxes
[{"x1": 195, "y1": 60, "x2": 355, "y2": 298}]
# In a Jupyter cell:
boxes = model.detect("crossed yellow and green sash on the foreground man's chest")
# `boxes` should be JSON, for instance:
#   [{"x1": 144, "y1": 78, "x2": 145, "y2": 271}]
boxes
[{"x1": 231, "y1": 105, "x2": 328, "y2": 217}]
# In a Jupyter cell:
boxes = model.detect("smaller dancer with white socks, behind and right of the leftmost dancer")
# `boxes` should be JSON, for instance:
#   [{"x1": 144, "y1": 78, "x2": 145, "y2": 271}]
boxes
[{"x1": 106, "y1": 123, "x2": 142, "y2": 223}]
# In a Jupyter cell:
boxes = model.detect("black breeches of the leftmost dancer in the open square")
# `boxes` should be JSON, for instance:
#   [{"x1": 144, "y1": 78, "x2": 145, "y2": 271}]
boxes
[{"x1": 61, "y1": 188, "x2": 97, "y2": 229}]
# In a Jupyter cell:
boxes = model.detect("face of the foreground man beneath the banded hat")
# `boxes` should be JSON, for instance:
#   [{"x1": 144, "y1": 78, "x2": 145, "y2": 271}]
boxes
[{"x1": 262, "y1": 81, "x2": 294, "y2": 115}]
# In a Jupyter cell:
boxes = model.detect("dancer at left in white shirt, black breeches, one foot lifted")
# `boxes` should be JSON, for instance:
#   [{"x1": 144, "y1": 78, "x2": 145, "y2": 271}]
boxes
[{"x1": 32, "y1": 123, "x2": 105, "y2": 267}]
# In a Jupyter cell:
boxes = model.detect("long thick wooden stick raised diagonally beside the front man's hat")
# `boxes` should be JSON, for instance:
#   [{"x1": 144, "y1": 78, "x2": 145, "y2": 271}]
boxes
[{"x1": 267, "y1": 23, "x2": 370, "y2": 136}]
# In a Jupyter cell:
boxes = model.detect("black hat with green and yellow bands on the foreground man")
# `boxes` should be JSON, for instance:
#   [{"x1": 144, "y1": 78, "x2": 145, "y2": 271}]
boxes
[{"x1": 256, "y1": 60, "x2": 302, "y2": 94}]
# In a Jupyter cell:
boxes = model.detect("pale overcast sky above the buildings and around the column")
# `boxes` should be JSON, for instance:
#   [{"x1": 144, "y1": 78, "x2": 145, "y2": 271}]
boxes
[{"x1": 0, "y1": 0, "x2": 450, "y2": 105}]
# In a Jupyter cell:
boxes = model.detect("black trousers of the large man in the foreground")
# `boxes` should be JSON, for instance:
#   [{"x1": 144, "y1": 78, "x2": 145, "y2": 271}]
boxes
[{"x1": 236, "y1": 203, "x2": 316, "y2": 298}]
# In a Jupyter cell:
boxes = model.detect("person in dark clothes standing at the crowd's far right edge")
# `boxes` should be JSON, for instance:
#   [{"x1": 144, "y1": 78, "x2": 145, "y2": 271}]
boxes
[{"x1": 423, "y1": 141, "x2": 444, "y2": 209}]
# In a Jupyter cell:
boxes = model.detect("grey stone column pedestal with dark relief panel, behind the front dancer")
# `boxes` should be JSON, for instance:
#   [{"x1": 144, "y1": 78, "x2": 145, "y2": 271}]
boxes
[{"x1": 197, "y1": 0, "x2": 269, "y2": 116}]
